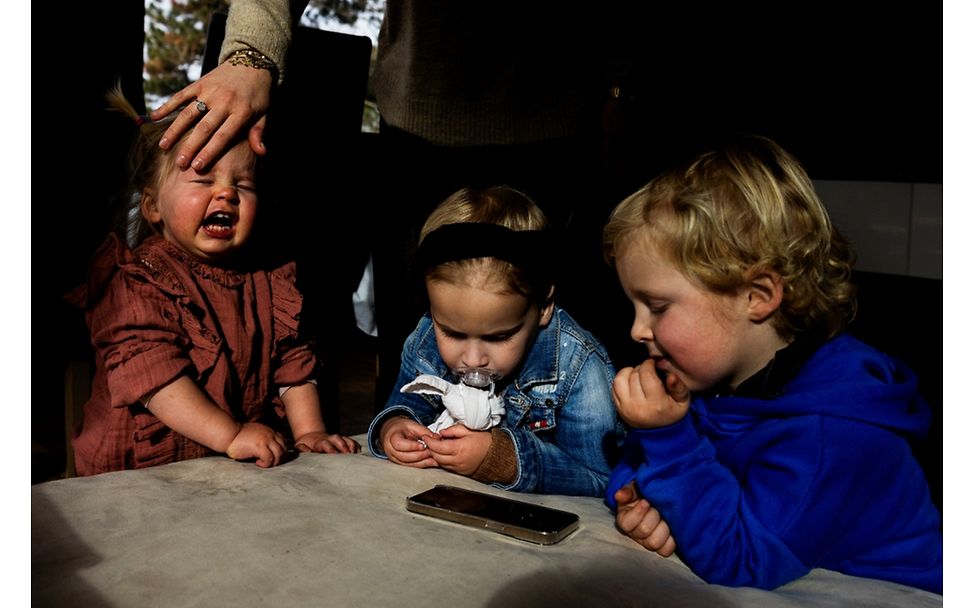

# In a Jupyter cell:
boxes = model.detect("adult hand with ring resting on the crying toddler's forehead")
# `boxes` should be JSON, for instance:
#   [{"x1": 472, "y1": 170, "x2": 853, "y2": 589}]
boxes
[{"x1": 152, "y1": 63, "x2": 274, "y2": 171}]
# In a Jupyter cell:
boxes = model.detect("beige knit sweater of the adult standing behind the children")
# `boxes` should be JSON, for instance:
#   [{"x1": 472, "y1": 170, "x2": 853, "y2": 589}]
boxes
[{"x1": 220, "y1": 0, "x2": 608, "y2": 146}]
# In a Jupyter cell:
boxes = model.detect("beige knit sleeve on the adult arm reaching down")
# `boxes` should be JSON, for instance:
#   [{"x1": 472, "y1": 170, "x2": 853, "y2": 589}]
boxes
[{"x1": 220, "y1": 0, "x2": 303, "y2": 84}]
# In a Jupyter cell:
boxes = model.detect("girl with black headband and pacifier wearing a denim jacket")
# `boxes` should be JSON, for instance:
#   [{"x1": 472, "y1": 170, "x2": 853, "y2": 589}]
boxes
[{"x1": 368, "y1": 187, "x2": 623, "y2": 496}]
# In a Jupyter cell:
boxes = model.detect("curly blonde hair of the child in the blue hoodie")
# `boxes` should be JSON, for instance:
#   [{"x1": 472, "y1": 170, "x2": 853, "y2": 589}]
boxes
[{"x1": 602, "y1": 136, "x2": 856, "y2": 339}]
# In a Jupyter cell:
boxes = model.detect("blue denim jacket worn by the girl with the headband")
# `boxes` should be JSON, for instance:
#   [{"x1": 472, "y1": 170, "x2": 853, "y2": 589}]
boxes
[{"x1": 368, "y1": 307, "x2": 624, "y2": 497}]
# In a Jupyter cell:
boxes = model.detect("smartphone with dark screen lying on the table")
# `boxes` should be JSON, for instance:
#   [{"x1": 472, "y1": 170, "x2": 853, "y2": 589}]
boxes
[{"x1": 406, "y1": 484, "x2": 578, "y2": 545}]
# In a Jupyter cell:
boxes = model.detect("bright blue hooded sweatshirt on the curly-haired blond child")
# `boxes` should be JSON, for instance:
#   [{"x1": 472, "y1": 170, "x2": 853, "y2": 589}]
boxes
[{"x1": 607, "y1": 335, "x2": 943, "y2": 594}]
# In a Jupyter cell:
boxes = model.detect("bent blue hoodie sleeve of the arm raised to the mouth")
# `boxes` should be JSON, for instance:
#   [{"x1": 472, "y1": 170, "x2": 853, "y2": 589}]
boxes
[{"x1": 608, "y1": 416, "x2": 817, "y2": 589}]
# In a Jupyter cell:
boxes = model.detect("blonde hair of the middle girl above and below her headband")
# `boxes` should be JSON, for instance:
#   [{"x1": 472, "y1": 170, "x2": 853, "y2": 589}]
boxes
[{"x1": 419, "y1": 186, "x2": 554, "y2": 307}]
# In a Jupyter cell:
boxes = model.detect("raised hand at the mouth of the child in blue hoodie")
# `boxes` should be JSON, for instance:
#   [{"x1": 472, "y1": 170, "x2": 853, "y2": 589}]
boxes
[{"x1": 612, "y1": 359, "x2": 690, "y2": 429}]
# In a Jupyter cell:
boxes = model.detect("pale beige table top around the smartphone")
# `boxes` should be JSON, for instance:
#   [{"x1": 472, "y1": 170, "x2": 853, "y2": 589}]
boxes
[{"x1": 31, "y1": 437, "x2": 943, "y2": 608}]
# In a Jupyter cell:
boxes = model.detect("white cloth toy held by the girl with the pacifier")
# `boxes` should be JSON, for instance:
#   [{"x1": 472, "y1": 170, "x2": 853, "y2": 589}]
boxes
[{"x1": 399, "y1": 374, "x2": 504, "y2": 433}]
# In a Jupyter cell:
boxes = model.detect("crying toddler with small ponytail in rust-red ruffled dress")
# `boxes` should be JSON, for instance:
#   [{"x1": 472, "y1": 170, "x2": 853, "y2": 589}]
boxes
[{"x1": 68, "y1": 86, "x2": 359, "y2": 475}]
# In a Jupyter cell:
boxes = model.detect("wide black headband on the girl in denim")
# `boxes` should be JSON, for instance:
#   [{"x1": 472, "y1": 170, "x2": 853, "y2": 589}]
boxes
[{"x1": 418, "y1": 222, "x2": 551, "y2": 272}]
